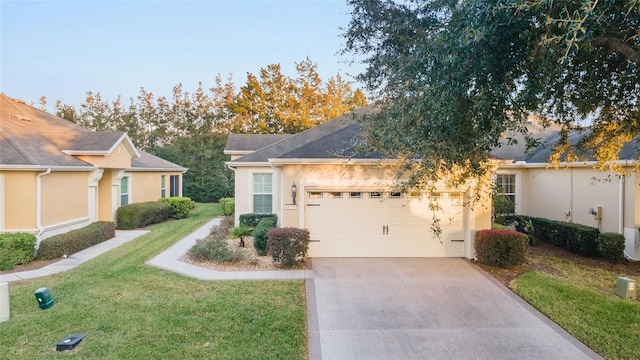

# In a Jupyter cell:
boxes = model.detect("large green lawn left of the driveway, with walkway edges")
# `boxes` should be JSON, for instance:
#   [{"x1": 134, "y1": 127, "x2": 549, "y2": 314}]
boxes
[{"x1": 0, "y1": 204, "x2": 307, "y2": 359}]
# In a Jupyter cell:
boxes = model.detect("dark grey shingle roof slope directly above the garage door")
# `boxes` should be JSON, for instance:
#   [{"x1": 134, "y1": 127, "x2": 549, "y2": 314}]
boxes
[{"x1": 232, "y1": 106, "x2": 376, "y2": 163}]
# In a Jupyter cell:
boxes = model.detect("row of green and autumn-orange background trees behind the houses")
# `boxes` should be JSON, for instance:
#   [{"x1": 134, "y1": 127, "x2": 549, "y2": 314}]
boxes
[{"x1": 50, "y1": 58, "x2": 367, "y2": 202}]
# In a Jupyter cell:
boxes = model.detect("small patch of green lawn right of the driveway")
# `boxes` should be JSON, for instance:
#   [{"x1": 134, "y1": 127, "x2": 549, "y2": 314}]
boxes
[{"x1": 512, "y1": 261, "x2": 640, "y2": 359}]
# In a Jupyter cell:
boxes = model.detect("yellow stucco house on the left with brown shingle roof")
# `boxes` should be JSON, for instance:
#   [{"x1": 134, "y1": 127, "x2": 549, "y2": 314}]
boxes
[{"x1": 0, "y1": 94, "x2": 186, "y2": 245}]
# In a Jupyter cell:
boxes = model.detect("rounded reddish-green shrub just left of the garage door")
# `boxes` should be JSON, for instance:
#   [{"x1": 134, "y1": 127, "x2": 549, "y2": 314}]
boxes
[{"x1": 267, "y1": 227, "x2": 310, "y2": 268}]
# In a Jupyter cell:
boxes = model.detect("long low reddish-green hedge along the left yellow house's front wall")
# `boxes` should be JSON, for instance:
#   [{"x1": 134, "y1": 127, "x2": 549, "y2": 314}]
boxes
[{"x1": 36, "y1": 221, "x2": 116, "y2": 260}]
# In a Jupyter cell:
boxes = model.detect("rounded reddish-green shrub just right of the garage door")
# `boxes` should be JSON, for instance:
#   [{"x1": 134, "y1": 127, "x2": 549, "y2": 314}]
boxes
[{"x1": 474, "y1": 230, "x2": 529, "y2": 268}]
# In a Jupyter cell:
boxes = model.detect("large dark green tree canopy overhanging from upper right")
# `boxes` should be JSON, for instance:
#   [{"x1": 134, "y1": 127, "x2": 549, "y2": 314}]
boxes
[{"x1": 343, "y1": 0, "x2": 640, "y2": 184}]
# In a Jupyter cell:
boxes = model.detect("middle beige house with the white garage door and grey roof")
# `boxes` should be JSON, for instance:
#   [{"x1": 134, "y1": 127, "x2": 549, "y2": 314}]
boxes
[{"x1": 225, "y1": 107, "x2": 491, "y2": 258}]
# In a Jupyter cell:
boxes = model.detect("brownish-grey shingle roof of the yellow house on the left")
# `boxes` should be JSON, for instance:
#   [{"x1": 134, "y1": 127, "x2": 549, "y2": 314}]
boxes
[{"x1": 0, "y1": 93, "x2": 186, "y2": 171}]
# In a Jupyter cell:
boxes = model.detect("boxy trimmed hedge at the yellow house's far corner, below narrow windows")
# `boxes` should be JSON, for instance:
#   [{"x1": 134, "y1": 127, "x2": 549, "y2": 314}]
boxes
[{"x1": 116, "y1": 201, "x2": 173, "y2": 230}]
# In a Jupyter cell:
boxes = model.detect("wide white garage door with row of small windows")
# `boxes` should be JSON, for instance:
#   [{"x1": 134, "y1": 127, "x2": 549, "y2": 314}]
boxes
[{"x1": 304, "y1": 190, "x2": 466, "y2": 257}]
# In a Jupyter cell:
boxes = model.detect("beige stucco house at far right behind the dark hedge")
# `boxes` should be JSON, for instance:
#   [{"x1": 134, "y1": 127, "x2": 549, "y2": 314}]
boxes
[{"x1": 493, "y1": 121, "x2": 640, "y2": 260}]
